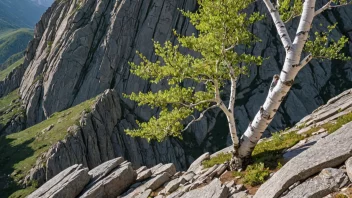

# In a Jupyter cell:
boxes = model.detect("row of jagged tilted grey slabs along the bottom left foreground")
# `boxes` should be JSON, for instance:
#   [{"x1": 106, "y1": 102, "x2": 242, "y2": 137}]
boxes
[{"x1": 29, "y1": 157, "x2": 236, "y2": 198}]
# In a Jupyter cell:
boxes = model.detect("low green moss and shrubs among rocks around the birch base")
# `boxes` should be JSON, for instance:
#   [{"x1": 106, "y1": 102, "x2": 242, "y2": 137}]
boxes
[{"x1": 203, "y1": 112, "x2": 352, "y2": 186}]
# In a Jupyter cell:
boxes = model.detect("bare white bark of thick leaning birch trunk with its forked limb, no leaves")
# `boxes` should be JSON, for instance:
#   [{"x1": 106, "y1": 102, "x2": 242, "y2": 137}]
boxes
[{"x1": 238, "y1": 0, "x2": 316, "y2": 158}]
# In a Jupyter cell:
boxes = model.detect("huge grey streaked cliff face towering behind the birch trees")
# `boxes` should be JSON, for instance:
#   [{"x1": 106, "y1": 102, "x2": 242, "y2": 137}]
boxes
[{"x1": 20, "y1": 0, "x2": 352, "y2": 151}]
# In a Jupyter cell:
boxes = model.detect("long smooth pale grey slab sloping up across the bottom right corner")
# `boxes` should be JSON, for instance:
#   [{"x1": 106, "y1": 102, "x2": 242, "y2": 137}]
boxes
[{"x1": 254, "y1": 123, "x2": 352, "y2": 198}]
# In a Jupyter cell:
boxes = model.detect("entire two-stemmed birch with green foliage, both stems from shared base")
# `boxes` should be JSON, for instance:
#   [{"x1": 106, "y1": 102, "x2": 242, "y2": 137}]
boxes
[{"x1": 125, "y1": 0, "x2": 348, "y2": 169}]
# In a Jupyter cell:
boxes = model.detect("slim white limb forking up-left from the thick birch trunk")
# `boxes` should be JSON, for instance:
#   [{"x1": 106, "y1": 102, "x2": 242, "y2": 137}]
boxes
[{"x1": 263, "y1": 0, "x2": 292, "y2": 52}]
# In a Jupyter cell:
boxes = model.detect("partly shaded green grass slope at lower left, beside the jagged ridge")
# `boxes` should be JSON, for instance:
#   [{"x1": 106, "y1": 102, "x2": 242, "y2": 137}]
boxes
[{"x1": 0, "y1": 99, "x2": 95, "y2": 197}]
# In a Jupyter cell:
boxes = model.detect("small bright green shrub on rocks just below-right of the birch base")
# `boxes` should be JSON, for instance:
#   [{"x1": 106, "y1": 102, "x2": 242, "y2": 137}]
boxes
[{"x1": 243, "y1": 163, "x2": 270, "y2": 186}]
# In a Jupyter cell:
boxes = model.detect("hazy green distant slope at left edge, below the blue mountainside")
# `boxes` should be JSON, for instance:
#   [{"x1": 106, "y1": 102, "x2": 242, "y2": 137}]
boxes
[{"x1": 0, "y1": 29, "x2": 33, "y2": 64}]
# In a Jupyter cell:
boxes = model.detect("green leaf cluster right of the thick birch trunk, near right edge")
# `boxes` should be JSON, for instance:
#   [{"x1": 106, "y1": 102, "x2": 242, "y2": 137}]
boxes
[{"x1": 304, "y1": 23, "x2": 351, "y2": 61}]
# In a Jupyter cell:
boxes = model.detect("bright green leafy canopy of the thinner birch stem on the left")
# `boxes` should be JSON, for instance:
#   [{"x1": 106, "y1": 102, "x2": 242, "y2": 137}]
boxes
[{"x1": 125, "y1": 0, "x2": 263, "y2": 141}]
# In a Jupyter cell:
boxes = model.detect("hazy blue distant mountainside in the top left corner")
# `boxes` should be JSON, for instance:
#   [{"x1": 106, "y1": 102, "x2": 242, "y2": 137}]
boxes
[{"x1": 0, "y1": 0, "x2": 49, "y2": 31}]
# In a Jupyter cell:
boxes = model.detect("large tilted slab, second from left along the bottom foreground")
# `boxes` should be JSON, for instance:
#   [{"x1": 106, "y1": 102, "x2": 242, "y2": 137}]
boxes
[{"x1": 80, "y1": 164, "x2": 137, "y2": 198}]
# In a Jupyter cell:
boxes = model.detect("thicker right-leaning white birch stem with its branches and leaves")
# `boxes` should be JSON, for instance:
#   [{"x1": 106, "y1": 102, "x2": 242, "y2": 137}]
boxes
[{"x1": 238, "y1": 0, "x2": 350, "y2": 162}]
